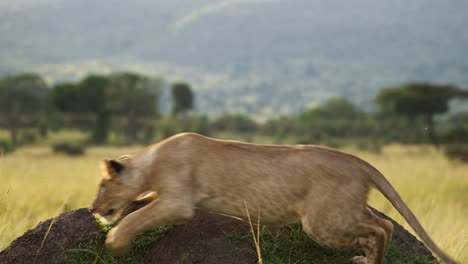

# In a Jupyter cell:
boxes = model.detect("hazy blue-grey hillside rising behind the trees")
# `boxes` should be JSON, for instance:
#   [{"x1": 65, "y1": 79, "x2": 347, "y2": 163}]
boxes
[{"x1": 0, "y1": 0, "x2": 468, "y2": 117}]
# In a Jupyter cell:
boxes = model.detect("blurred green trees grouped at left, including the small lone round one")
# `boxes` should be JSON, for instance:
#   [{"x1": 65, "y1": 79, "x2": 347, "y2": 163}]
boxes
[{"x1": 0, "y1": 72, "x2": 193, "y2": 145}]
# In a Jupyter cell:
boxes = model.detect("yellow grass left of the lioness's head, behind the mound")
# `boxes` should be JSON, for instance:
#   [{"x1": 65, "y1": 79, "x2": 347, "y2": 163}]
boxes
[{"x1": 0, "y1": 144, "x2": 141, "y2": 249}]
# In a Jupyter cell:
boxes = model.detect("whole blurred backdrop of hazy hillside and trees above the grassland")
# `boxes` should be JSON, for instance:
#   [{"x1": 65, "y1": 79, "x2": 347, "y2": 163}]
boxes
[{"x1": 0, "y1": 0, "x2": 468, "y2": 159}]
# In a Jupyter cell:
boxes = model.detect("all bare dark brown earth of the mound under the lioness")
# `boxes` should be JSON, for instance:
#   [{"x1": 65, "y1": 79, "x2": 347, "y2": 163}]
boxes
[{"x1": 0, "y1": 209, "x2": 433, "y2": 264}]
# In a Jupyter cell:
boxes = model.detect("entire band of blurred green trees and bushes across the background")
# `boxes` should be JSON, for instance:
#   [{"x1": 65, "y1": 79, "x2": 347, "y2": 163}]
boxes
[{"x1": 0, "y1": 72, "x2": 468, "y2": 153}]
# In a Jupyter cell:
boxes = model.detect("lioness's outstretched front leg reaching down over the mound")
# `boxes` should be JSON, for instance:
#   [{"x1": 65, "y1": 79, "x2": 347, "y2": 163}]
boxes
[{"x1": 106, "y1": 200, "x2": 194, "y2": 256}]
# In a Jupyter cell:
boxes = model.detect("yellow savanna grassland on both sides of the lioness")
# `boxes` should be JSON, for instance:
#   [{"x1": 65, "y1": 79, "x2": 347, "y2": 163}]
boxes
[{"x1": 0, "y1": 140, "x2": 468, "y2": 263}]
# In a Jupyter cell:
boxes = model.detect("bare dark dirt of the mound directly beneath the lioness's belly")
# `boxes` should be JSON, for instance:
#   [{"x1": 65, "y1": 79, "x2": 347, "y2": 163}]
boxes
[{"x1": 143, "y1": 211, "x2": 257, "y2": 264}]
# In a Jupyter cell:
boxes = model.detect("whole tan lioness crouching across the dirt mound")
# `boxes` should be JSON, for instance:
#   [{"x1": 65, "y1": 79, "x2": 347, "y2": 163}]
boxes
[{"x1": 92, "y1": 133, "x2": 456, "y2": 264}]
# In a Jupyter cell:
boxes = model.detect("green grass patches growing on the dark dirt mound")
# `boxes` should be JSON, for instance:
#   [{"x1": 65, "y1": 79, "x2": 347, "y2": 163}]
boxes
[{"x1": 70, "y1": 224, "x2": 439, "y2": 264}]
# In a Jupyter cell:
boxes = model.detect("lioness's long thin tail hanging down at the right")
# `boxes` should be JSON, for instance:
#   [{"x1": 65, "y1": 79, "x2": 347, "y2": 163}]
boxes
[{"x1": 369, "y1": 167, "x2": 458, "y2": 264}]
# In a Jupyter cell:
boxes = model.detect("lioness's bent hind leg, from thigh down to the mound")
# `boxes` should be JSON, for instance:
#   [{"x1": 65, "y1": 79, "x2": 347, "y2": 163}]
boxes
[{"x1": 300, "y1": 190, "x2": 391, "y2": 264}]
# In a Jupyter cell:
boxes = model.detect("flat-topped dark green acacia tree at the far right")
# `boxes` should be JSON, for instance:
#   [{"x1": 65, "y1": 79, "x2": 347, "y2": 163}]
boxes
[{"x1": 375, "y1": 83, "x2": 468, "y2": 145}]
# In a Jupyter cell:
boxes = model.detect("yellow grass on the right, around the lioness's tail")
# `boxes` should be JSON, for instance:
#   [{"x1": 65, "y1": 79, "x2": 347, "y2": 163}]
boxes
[{"x1": 351, "y1": 145, "x2": 468, "y2": 263}]
